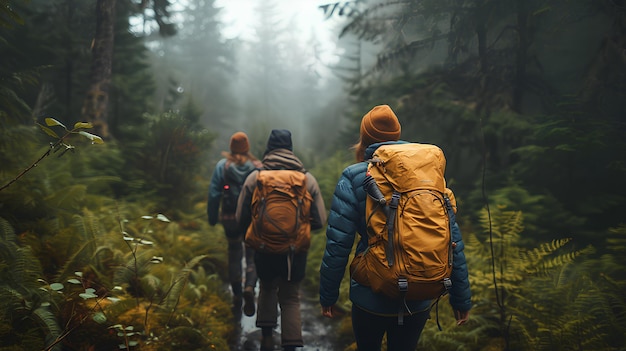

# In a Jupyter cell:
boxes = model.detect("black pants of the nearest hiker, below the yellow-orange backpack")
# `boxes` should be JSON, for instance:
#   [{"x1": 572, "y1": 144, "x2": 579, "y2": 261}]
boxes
[{"x1": 352, "y1": 305, "x2": 430, "y2": 351}]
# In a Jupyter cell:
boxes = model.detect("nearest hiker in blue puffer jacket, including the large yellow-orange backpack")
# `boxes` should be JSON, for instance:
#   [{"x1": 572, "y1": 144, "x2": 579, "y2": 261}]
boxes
[{"x1": 320, "y1": 105, "x2": 471, "y2": 351}]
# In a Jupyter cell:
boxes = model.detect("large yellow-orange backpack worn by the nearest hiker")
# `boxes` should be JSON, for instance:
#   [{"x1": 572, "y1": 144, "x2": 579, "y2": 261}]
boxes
[{"x1": 350, "y1": 143, "x2": 456, "y2": 321}]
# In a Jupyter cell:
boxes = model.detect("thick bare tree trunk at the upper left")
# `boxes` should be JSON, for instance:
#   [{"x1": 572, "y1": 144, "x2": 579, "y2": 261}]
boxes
[{"x1": 82, "y1": 0, "x2": 116, "y2": 137}]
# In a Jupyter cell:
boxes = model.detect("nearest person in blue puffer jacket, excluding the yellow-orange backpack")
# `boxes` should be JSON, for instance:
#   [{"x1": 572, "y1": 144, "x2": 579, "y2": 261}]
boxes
[{"x1": 320, "y1": 105, "x2": 471, "y2": 351}]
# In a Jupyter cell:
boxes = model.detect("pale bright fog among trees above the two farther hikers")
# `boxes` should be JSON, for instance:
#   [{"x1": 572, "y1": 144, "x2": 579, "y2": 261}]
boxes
[{"x1": 141, "y1": 0, "x2": 364, "y2": 160}]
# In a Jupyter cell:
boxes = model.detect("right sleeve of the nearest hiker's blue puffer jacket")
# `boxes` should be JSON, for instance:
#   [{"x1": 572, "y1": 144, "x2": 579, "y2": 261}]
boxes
[{"x1": 449, "y1": 191, "x2": 472, "y2": 311}]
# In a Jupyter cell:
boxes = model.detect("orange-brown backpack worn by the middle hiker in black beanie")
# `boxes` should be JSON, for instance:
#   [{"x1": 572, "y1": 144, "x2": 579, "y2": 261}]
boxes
[{"x1": 245, "y1": 170, "x2": 313, "y2": 255}]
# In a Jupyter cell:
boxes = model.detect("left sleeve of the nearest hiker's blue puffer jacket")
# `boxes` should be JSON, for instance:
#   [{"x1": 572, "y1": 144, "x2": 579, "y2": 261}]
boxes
[{"x1": 320, "y1": 167, "x2": 360, "y2": 306}]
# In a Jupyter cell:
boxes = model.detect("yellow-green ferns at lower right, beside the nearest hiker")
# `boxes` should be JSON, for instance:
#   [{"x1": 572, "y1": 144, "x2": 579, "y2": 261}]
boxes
[{"x1": 465, "y1": 210, "x2": 624, "y2": 350}]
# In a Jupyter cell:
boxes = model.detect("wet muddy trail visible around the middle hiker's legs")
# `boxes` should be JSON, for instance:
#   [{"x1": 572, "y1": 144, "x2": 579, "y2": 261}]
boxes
[{"x1": 231, "y1": 291, "x2": 339, "y2": 351}]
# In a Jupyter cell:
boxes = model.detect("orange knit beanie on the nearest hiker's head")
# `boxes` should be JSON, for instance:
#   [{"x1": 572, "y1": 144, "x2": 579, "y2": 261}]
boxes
[{"x1": 361, "y1": 105, "x2": 401, "y2": 146}]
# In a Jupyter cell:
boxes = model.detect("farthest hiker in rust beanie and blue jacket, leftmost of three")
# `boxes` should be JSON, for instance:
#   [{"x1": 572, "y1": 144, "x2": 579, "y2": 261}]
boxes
[{"x1": 207, "y1": 132, "x2": 262, "y2": 316}]
